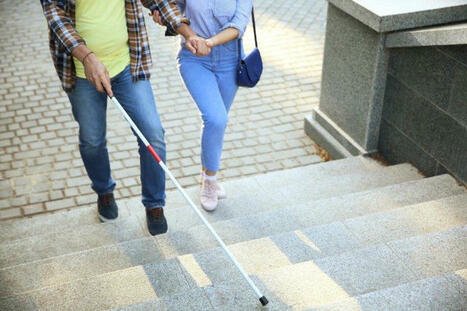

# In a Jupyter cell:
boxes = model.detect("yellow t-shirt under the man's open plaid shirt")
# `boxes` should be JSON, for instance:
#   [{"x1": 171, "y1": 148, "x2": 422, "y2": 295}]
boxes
[{"x1": 74, "y1": 0, "x2": 130, "y2": 78}]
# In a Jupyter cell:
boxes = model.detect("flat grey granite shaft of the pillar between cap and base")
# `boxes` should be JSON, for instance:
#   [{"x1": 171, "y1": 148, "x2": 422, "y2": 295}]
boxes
[{"x1": 319, "y1": 5, "x2": 387, "y2": 152}]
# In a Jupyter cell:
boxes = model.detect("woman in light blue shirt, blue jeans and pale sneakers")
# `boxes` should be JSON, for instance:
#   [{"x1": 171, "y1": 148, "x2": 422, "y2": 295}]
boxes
[{"x1": 156, "y1": 0, "x2": 253, "y2": 211}]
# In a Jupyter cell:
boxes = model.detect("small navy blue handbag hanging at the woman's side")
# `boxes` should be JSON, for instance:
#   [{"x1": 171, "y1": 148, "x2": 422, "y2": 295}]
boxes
[{"x1": 237, "y1": 9, "x2": 263, "y2": 87}]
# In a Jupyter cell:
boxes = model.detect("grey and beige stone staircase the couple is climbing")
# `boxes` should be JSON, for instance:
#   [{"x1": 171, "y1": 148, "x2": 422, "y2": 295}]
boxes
[{"x1": 0, "y1": 157, "x2": 467, "y2": 310}]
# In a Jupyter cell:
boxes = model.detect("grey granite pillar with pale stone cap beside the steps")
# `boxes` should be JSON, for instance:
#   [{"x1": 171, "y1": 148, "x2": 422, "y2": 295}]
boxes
[{"x1": 305, "y1": 0, "x2": 467, "y2": 158}]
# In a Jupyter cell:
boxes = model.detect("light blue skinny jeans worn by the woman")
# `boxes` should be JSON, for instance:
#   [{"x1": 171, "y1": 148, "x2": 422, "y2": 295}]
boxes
[{"x1": 178, "y1": 40, "x2": 238, "y2": 172}]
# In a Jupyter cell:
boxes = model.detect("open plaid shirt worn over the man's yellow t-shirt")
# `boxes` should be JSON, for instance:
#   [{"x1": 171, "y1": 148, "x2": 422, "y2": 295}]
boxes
[{"x1": 41, "y1": 0, "x2": 189, "y2": 93}]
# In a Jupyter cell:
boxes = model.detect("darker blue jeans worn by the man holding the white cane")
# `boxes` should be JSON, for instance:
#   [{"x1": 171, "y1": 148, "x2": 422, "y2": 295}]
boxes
[{"x1": 68, "y1": 66, "x2": 165, "y2": 208}]
